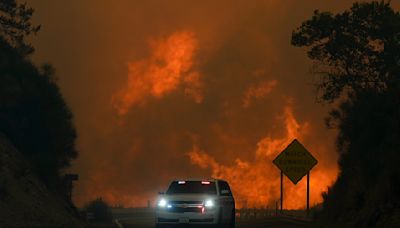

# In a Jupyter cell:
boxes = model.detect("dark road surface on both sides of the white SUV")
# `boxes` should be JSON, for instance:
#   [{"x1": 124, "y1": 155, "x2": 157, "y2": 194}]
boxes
[{"x1": 114, "y1": 209, "x2": 310, "y2": 228}]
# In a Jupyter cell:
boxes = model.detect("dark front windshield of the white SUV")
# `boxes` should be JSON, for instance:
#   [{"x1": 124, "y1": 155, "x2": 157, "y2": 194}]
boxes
[{"x1": 167, "y1": 181, "x2": 217, "y2": 195}]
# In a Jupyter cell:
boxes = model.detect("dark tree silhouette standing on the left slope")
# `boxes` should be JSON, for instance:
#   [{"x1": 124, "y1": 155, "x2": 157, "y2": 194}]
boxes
[{"x1": 0, "y1": 0, "x2": 77, "y2": 188}]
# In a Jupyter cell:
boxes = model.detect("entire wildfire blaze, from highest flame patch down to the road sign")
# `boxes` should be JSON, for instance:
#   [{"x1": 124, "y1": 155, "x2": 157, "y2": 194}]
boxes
[{"x1": 81, "y1": 31, "x2": 337, "y2": 209}]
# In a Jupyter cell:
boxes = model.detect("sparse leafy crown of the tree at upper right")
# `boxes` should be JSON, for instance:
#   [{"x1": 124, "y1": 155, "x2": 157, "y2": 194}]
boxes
[{"x1": 292, "y1": 1, "x2": 400, "y2": 102}]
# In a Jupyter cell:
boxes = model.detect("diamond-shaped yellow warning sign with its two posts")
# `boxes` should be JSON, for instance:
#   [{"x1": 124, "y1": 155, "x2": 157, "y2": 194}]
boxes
[{"x1": 272, "y1": 139, "x2": 318, "y2": 213}]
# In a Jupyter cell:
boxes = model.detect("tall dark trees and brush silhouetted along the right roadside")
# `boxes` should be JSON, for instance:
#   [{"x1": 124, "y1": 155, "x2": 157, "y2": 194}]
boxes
[{"x1": 292, "y1": 1, "x2": 400, "y2": 227}]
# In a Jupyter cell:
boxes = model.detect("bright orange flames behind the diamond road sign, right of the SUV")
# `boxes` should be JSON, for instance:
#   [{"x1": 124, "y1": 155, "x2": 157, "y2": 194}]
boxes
[{"x1": 188, "y1": 106, "x2": 336, "y2": 209}]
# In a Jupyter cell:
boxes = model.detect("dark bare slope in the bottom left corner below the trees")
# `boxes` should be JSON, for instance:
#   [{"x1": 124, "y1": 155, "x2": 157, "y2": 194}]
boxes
[{"x1": 0, "y1": 135, "x2": 84, "y2": 228}]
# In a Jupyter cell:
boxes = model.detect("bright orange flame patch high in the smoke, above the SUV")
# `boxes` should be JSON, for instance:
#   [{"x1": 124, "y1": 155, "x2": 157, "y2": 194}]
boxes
[{"x1": 112, "y1": 31, "x2": 203, "y2": 115}]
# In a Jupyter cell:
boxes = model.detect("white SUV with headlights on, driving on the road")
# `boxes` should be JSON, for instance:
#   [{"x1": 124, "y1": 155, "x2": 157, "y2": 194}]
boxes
[{"x1": 155, "y1": 179, "x2": 235, "y2": 228}]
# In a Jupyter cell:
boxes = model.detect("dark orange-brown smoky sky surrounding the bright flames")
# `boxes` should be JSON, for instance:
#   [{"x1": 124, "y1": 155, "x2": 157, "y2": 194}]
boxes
[{"x1": 28, "y1": 0, "x2": 399, "y2": 206}]
